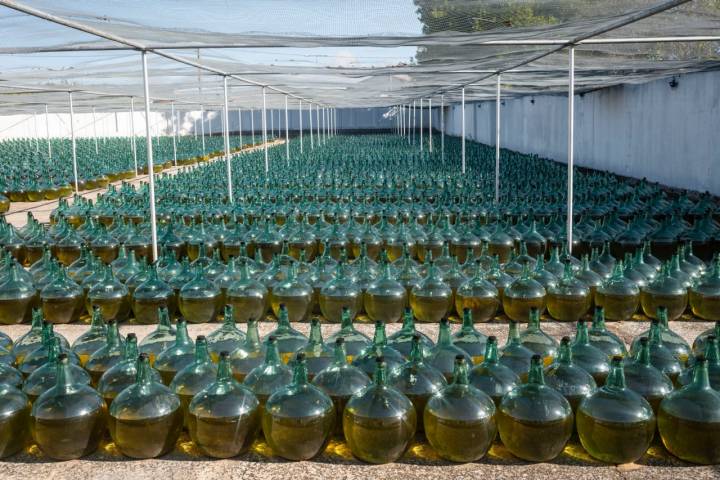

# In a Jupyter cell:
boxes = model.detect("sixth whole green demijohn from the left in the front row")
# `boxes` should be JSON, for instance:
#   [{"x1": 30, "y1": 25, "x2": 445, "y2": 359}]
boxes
[{"x1": 423, "y1": 356, "x2": 497, "y2": 462}]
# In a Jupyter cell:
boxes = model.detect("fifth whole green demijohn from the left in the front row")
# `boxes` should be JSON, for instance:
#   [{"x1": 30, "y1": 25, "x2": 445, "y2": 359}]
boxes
[{"x1": 343, "y1": 355, "x2": 417, "y2": 463}]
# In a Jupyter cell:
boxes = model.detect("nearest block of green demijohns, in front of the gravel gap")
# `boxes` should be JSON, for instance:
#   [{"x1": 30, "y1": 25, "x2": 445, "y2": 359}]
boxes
[{"x1": 0, "y1": 304, "x2": 720, "y2": 464}]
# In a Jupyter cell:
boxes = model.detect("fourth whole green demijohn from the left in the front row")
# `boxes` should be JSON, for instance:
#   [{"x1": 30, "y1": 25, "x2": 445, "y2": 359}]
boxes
[{"x1": 262, "y1": 352, "x2": 336, "y2": 460}]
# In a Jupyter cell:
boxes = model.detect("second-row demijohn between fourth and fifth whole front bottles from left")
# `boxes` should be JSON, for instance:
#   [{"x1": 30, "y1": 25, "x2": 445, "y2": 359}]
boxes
[{"x1": 312, "y1": 337, "x2": 370, "y2": 435}]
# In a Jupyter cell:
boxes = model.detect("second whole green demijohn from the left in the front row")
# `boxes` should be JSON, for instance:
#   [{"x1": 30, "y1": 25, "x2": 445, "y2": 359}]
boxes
[{"x1": 108, "y1": 353, "x2": 183, "y2": 458}]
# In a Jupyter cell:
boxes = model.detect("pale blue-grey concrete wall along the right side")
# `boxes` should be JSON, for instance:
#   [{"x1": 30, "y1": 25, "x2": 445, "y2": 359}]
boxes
[{"x1": 436, "y1": 72, "x2": 720, "y2": 195}]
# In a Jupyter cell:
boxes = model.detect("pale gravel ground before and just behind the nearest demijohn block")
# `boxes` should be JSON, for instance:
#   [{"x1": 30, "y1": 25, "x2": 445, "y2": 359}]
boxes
[{"x1": 0, "y1": 319, "x2": 720, "y2": 480}]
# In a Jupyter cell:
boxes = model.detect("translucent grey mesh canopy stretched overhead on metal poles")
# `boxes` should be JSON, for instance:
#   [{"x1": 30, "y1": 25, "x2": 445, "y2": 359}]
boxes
[{"x1": 0, "y1": 0, "x2": 720, "y2": 114}]
